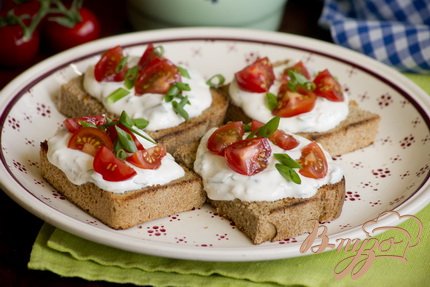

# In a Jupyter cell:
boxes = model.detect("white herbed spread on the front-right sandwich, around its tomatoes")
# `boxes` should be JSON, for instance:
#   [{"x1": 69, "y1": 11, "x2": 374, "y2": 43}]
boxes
[{"x1": 194, "y1": 128, "x2": 343, "y2": 201}]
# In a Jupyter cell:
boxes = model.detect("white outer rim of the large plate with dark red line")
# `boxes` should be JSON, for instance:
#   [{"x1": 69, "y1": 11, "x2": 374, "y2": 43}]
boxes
[{"x1": 0, "y1": 28, "x2": 430, "y2": 261}]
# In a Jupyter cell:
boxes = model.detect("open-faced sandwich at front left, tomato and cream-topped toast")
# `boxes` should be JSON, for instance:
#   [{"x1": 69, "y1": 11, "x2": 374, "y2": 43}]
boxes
[{"x1": 40, "y1": 112, "x2": 206, "y2": 229}]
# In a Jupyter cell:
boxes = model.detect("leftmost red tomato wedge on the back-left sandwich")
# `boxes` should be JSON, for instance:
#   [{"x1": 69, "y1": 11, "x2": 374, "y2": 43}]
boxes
[{"x1": 94, "y1": 46, "x2": 128, "y2": 82}]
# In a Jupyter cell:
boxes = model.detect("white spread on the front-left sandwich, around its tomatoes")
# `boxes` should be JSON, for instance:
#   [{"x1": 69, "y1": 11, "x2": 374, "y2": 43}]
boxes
[{"x1": 48, "y1": 129, "x2": 185, "y2": 193}]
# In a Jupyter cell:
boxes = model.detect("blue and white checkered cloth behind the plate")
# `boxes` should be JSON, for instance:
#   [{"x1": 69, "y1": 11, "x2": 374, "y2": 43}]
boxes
[{"x1": 319, "y1": 0, "x2": 430, "y2": 73}]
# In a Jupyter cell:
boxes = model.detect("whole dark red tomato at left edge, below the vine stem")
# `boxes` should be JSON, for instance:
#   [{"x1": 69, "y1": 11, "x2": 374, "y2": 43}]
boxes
[{"x1": 0, "y1": 25, "x2": 39, "y2": 67}]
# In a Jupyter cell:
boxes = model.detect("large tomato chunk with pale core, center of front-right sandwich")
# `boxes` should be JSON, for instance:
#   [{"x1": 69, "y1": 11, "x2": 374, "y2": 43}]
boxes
[{"x1": 224, "y1": 138, "x2": 272, "y2": 175}]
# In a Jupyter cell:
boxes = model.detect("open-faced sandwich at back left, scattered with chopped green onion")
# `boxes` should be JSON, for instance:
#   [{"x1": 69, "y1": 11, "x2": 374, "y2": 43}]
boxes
[{"x1": 55, "y1": 44, "x2": 228, "y2": 155}]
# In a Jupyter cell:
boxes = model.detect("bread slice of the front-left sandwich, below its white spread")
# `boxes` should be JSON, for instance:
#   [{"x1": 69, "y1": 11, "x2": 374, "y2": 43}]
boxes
[{"x1": 40, "y1": 141, "x2": 206, "y2": 229}]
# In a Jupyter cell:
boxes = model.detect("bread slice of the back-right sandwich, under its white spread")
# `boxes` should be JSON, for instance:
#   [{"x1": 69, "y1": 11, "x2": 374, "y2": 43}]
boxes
[{"x1": 226, "y1": 101, "x2": 380, "y2": 156}]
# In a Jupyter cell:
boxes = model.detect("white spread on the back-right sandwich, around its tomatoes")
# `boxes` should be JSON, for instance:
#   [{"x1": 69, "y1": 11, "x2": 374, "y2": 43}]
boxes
[{"x1": 229, "y1": 70, "x2": 349, "y2": 133}]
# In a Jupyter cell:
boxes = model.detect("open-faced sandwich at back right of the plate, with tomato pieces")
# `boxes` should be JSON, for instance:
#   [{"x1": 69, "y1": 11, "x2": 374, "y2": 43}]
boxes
[{"x1": 227, "y1": 57, "x2": 379, "y2": 155}]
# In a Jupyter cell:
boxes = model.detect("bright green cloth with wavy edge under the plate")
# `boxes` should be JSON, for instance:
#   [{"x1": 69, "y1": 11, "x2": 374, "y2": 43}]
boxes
[{"x1": 28, "y1": 74, "x2": 430, "y2": 287}]
